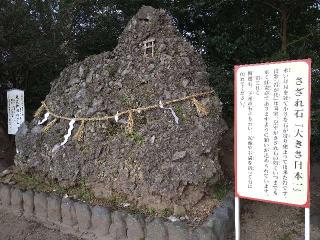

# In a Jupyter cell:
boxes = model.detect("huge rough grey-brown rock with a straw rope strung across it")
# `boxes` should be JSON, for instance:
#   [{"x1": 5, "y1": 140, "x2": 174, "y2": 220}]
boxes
[{"x1": 15, "y1": 7, "x2": 226, "y2": 209}]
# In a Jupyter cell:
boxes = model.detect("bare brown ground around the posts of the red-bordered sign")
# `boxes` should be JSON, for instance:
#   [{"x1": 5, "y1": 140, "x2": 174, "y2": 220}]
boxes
[{"x1": 228, "y1": 160, "x2": 320, "y2": 240}]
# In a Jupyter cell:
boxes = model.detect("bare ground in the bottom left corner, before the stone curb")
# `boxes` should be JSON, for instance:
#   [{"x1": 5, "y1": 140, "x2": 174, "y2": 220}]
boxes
[{"x1": 0, "y1": 211, "x2": 78, "y2": 240}]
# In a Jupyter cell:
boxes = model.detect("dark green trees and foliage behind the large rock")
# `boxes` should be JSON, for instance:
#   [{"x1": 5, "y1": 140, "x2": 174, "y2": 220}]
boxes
[{"x1": 0, "y1": 0, "x2": 320, "y2": 158}]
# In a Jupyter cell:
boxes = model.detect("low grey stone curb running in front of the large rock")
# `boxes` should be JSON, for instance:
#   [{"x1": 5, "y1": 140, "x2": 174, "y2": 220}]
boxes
[{"x1": 0, "y1": 183, "x2": 234, "y2": 240}]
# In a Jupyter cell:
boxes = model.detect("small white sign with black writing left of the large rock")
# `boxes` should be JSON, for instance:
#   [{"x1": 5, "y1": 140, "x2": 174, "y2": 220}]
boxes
[{"x1": 7, "y1": 89, "x2": 25, "y2": 135}]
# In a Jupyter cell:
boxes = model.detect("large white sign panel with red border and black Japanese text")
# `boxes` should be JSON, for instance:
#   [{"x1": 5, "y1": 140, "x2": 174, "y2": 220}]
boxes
[{"x1": 235, "y1": 59, "x2": 311, "y2": 207}]
